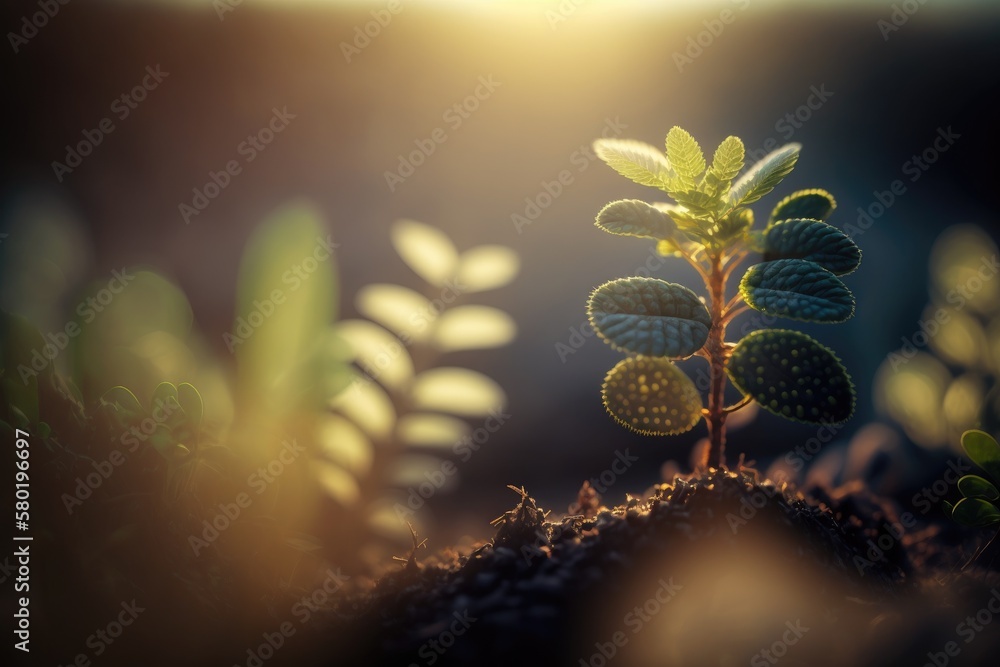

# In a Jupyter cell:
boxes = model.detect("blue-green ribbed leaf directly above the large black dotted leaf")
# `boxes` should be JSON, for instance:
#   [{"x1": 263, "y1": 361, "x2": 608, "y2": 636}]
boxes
[{"x1": 740, "y1": 259, "x2": 854, "y2": 323}]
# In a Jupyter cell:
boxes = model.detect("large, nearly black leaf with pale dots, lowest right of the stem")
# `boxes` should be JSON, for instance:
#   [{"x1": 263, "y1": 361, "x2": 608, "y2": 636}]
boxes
[{"x1": 726, "y1": 329, "x2": 855, "y2": 424}]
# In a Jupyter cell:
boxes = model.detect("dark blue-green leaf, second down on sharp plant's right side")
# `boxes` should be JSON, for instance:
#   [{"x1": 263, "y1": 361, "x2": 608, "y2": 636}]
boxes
[{"x1": 764, "y1": 218, "x2": 861, "y2": 276}]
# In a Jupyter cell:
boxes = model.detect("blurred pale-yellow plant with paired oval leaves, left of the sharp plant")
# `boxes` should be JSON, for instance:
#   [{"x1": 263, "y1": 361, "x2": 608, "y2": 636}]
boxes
[{"x1": 332, "y1": 220, "x2": 520, "y2": 542}]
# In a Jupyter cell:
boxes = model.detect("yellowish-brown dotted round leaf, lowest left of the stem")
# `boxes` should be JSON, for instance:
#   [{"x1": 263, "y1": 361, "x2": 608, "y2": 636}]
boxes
[{"x1": 601, "y1": 357, "x2": 701, "y2": 435}]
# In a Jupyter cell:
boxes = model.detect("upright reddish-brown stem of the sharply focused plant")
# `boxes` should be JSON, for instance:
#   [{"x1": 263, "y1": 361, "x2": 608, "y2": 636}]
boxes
[{"x1": 702, "y1": 253, "x2": 728, "y2": 469}]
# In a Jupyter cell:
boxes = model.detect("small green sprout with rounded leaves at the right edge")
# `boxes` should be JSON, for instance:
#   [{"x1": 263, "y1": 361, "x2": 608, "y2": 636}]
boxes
[{"x1": 944, "y1": 430, "x2": 1000, "y2": 528}]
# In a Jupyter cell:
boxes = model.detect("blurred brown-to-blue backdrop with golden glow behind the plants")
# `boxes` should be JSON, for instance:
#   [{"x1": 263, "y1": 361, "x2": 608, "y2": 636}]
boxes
[{"x1": 0, "y1": 0, "x2": 1000, "y2": 588}]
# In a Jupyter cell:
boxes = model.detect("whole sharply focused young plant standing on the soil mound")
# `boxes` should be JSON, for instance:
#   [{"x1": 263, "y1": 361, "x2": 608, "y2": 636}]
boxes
[{"x1": 587, "y1": 127, "x2": 861, "y2": 468}]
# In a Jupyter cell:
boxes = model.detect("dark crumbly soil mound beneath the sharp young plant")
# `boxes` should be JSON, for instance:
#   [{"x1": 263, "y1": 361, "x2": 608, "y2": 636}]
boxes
[{"x1": 331, "y1": 469, "x2": 1000, "y2": 667}]
